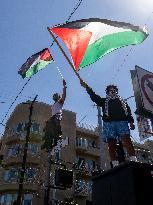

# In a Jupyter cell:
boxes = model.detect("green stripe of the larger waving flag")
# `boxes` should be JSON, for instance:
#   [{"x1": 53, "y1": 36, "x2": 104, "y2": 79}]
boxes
[{"x1": 79, "y1": 31, "x2": 146, "y2": 68}]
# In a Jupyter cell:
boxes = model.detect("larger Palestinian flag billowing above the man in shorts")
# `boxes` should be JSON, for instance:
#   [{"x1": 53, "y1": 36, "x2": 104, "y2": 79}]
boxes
[{"x1": 49, "y1": 18, "x2": 148, "y2": 70}]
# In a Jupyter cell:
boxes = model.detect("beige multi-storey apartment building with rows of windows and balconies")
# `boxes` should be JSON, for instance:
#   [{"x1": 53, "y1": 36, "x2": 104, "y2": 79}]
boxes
[{"x1": 0, "y1": 102, "x2": 103, "y2": 205}]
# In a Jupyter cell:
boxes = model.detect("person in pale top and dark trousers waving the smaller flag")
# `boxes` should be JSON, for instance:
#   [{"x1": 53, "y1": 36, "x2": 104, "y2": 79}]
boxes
[{"x1": 42, "y1": 79, "x2": 67, "y2": 150}]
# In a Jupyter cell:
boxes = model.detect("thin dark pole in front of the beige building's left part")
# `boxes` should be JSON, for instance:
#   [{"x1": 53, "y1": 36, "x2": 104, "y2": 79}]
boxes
[{"x1": 17, "y1": 95, "x2": 38, "y2": 205}]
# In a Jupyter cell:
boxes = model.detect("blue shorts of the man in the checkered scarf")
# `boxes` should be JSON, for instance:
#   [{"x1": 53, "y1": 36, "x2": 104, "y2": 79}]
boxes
[{"x1": 103, "y1": 121, "x2": 130, "y2": 142}]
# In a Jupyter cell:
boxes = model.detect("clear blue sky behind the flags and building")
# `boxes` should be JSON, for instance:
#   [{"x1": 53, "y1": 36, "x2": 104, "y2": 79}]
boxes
[{"x1": 0, "y1": 0, "x2": 153, "y2": 142}]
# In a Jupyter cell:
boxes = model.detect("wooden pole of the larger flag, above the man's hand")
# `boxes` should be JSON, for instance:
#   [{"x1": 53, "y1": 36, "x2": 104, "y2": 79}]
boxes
[{"x1": 47, "y1": 27, "x2": 81, "y2": 80}]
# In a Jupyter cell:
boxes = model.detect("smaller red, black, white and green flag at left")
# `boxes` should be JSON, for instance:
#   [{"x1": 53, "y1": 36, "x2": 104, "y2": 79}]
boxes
[{"x1": 18, "y1": 48, "x2": 53, "y2": 78}]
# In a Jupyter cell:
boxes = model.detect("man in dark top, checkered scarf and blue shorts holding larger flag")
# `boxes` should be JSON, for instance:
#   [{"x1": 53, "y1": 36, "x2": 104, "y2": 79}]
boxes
[{"x1": 80, "y1": 79, "x2": 137, "y2": 167}]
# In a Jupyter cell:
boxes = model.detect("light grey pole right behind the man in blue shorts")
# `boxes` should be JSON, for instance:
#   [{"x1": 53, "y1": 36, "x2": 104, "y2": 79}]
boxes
[{"x1": 97, "y1": 106, "x2": 109, "y2": 170}]
